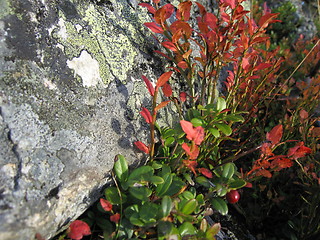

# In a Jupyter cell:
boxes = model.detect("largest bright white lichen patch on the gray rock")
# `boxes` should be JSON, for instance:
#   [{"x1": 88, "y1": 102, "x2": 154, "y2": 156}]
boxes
[{"x1": 67, "y1": 50, "x2": 101, "y2": 87}]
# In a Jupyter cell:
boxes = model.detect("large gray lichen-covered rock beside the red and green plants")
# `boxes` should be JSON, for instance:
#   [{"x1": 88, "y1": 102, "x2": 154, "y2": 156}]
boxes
[{"x1": 0, "y1": 0, "x2": 163, "y2": 240}]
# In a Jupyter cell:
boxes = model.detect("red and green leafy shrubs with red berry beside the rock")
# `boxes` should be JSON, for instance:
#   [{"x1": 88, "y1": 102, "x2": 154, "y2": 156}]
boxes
[{"x1": 51, "y1": 0, "x2": 320, "y2": 240}]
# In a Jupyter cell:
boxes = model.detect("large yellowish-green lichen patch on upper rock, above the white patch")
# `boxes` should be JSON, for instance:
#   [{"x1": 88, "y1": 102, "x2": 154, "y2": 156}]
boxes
[{"x1": 55, "y1": 1, "x2": 151, "y2": 84}]
